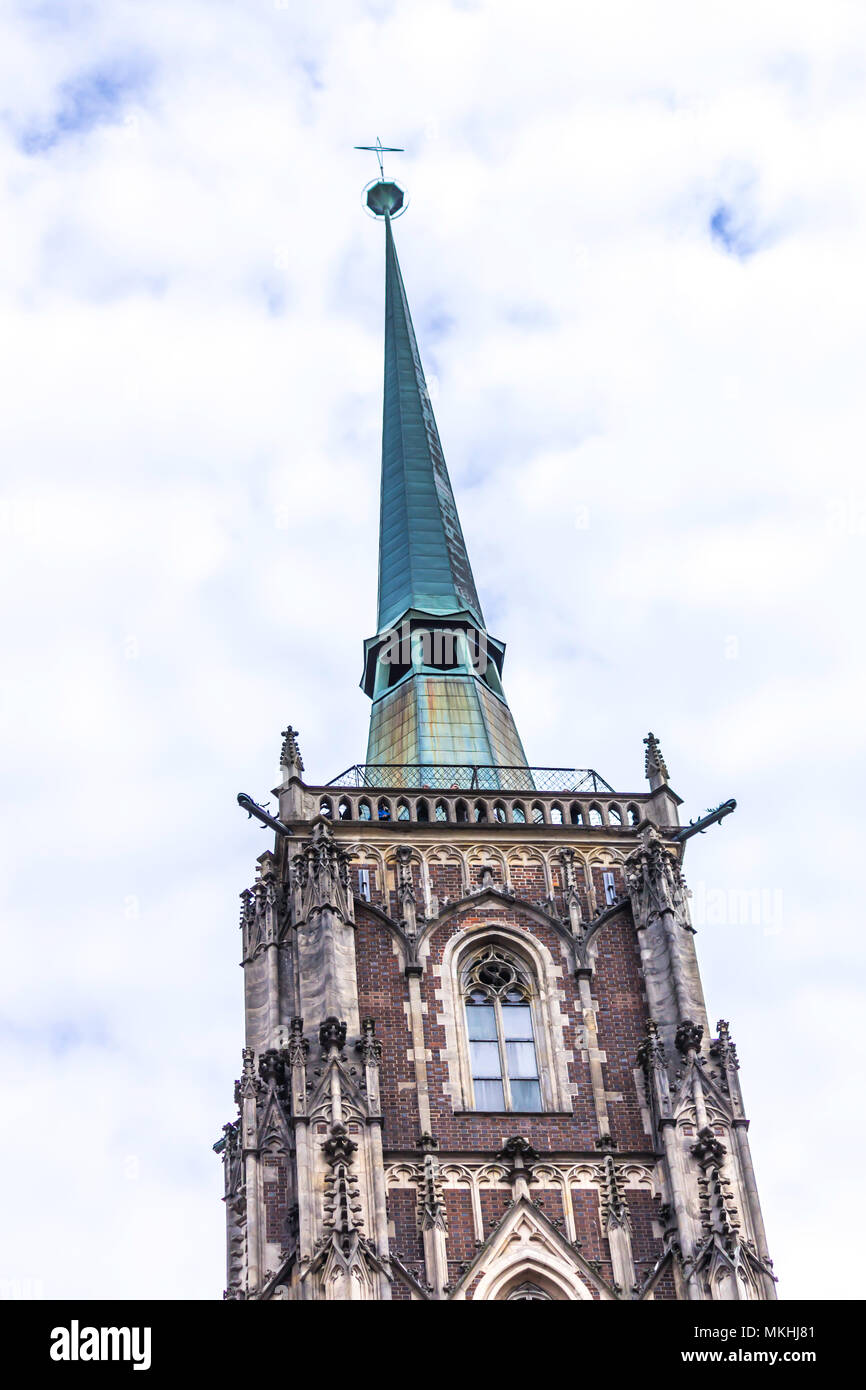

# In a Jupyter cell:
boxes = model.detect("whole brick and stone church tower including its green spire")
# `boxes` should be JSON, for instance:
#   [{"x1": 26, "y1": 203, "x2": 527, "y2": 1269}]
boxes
[{"x1": 214, "y1": 168, "x2": 776, "y2": 1301}]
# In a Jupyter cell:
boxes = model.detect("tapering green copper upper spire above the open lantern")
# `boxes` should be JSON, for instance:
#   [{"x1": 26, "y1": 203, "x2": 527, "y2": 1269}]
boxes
[{"x1": 370, "y1": 207, "x2": 484, "y2": 632}]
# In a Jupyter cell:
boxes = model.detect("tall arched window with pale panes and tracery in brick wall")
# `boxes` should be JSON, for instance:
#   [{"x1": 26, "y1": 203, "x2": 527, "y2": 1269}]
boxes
[{"x1": 463, "y1": 947, "x2": 541, "y2": 1112}]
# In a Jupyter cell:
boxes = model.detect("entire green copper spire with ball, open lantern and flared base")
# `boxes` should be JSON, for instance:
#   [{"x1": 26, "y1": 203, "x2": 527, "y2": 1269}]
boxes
[{"x1": 361, "y1": 179, "x2": 525, "y2": 787}]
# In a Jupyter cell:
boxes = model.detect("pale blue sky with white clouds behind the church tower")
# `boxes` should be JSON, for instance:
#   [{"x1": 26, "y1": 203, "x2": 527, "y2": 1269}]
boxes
[{"x1": 0, "y1": 0, "x2": 866, "y2": 1298}]
